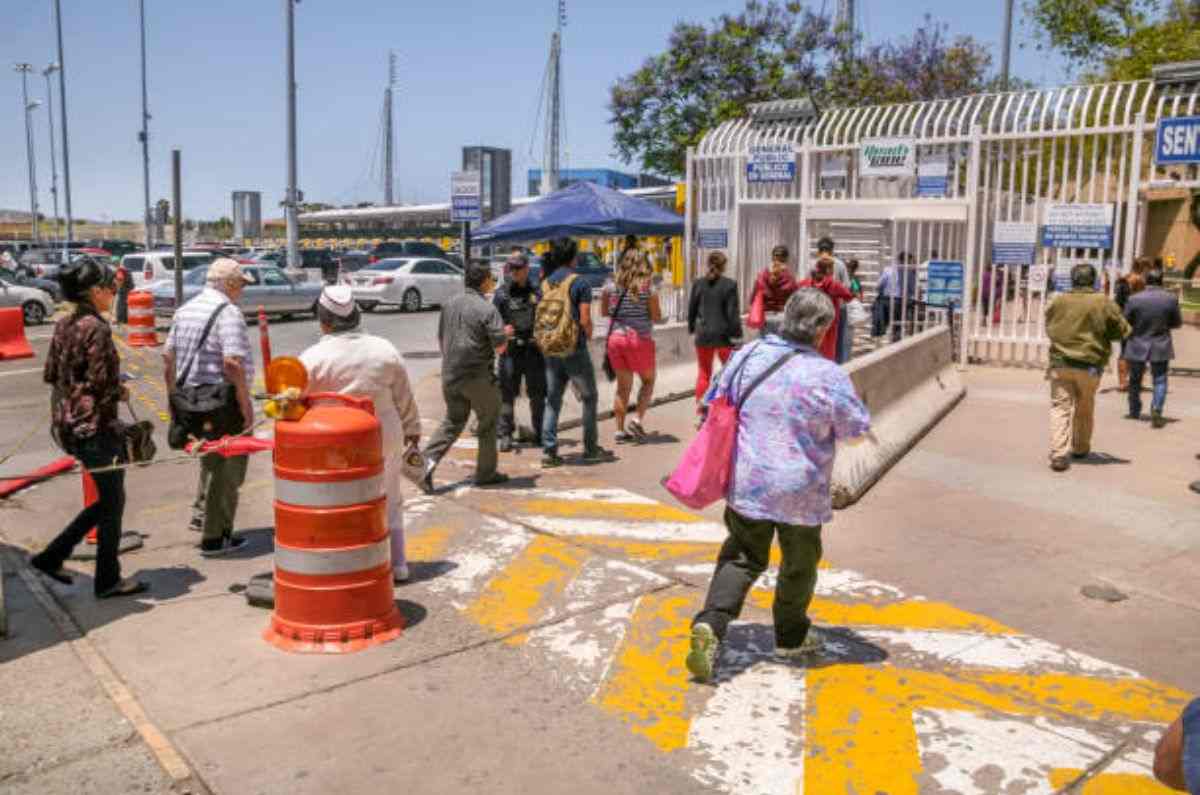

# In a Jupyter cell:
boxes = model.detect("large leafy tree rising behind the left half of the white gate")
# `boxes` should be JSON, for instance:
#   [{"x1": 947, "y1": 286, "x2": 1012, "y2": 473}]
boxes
[{"x1": 608, "y1": 0, "x2": 994, "y2": 175}]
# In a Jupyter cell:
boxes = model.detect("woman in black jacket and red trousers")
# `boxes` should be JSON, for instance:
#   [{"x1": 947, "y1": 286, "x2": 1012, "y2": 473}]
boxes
[{"x1": 688, "y1": 251, "x2": 742, "y2": 417}]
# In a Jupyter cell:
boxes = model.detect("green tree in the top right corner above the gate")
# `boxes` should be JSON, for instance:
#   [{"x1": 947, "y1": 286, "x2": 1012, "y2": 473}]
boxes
[{"x1": 1025, "y1": 0, "x2": 1200, "y2": 80}]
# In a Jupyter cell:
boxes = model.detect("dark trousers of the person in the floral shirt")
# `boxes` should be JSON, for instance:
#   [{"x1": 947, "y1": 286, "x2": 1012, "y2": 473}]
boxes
[{"x1": 692, "y1": 508, "x2": 822, "y2": 648}]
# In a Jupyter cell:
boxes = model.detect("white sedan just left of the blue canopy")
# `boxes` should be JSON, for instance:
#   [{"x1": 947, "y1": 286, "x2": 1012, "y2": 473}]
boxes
[{"x1": 342, "y1": 258, "x2": 464, "y2": 312}]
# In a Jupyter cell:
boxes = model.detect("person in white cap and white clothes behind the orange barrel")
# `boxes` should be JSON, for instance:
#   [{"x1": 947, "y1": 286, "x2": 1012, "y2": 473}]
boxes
[{"x1": 300, "y1": 286, "x2": 421, "y2": 582}]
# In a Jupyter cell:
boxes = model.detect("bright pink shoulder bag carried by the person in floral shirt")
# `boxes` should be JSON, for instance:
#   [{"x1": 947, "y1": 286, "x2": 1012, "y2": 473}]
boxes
[{"x1": 662, "y1": 395, "x2": 738, "y2": 509}]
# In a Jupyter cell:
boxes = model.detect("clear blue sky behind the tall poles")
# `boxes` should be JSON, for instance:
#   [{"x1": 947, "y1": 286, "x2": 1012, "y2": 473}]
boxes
[{"x1": 0, "y1": 0, "x2": 1066, "y2": 224}]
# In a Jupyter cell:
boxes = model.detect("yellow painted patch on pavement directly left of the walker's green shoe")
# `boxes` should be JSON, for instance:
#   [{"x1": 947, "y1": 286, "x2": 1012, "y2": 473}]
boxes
[{"x1": 593, "y1": 588, "x2": 702, "y2": 751}]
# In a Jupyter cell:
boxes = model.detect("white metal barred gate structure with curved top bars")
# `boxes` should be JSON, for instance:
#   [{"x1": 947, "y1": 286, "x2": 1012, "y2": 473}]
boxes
[{"x1": 685, "y1": 80, "x2": 1200, "y2": 365}]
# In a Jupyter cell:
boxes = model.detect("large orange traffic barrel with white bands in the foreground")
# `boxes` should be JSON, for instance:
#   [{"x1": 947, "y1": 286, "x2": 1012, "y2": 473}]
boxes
[{"x1": 263, "y1": 393, "x2": 403, "y2": 653}]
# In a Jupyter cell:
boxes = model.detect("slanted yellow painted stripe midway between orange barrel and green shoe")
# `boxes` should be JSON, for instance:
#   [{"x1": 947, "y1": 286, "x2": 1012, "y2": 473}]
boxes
[{"x1": 467, "y1": 536, "x2": 590, "y2": 634}]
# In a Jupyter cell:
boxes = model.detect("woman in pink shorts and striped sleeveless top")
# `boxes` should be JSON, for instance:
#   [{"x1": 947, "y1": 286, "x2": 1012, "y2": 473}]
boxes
[{"x1": 600, "y1": 247, "x2": 662, "y2": 444}]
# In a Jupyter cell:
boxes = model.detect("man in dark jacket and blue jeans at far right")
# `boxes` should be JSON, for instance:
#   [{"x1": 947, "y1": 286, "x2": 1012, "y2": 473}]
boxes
[{"x1": 1121, "y1": 270, "x2": 1183, "y2": 428}]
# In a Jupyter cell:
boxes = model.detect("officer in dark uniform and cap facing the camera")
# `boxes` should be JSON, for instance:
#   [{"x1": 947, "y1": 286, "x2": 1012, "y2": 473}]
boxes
[{"x1": 492, "y1": 249, "x2": 546, "y2": 453}]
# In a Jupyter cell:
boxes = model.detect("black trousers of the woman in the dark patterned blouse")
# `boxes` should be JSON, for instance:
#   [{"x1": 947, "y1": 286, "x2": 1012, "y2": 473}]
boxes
[{"x1": 32, "y1": 435, "x2": 125, "y2": 596}]
